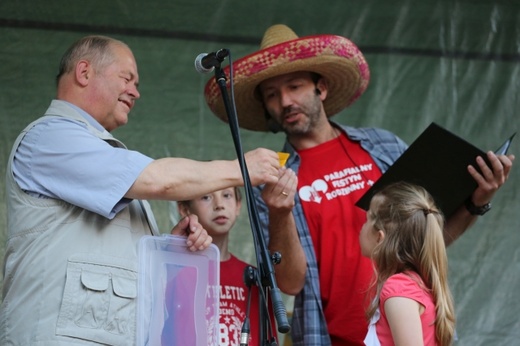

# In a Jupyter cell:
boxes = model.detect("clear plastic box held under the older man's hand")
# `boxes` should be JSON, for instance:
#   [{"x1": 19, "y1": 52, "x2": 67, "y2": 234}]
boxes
[{"x1": 137, "y1": 235, "x2": 220, "y2": 346}]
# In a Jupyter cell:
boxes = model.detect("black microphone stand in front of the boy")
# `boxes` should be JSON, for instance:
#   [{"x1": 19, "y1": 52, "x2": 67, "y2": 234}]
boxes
[{"x1": 215, "y1": 53, "x2": 290, "y2": 346}]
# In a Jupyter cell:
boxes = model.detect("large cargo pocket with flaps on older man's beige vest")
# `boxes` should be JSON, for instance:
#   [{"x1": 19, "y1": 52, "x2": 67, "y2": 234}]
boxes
[{"x1": 56, "y1": 255, "x2": 137, "y2": 346}]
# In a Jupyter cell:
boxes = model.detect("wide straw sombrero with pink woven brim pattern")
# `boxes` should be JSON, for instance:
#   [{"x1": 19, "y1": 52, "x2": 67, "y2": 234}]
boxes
[{"x1": 204, "y1": 24, "x2": 370, "y2": 131}]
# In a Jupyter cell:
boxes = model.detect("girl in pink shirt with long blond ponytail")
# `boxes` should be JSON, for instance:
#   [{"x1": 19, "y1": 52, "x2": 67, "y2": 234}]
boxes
[{"x1": 359, "y1": 182, "x2": 455, "y2": 346}]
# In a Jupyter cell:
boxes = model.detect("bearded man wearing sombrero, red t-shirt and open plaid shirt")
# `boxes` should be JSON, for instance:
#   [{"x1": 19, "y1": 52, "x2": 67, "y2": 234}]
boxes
[{"x1": 205, "y1": 25, "x2": 513, "y2": 346}]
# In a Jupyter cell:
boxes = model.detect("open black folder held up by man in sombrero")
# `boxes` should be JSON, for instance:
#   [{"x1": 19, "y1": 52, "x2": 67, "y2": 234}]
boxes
[{"x1": 356, "y1": 123, "x2": 516, "y2": 217}]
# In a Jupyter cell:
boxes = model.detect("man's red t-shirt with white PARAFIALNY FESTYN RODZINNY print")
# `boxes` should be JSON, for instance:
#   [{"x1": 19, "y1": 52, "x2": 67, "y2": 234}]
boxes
[{"x1": 298, "y1": 134, "x2": 381, "y2": 346}]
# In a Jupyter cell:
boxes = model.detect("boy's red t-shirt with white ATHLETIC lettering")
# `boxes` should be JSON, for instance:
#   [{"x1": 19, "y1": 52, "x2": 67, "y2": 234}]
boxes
[{"x1": 219, "y1": 255, "x2": 276, "y2": 346}]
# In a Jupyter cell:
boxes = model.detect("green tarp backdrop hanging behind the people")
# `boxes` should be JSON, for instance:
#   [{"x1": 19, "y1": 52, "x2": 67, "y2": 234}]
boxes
[{"x1": 0, "y1": 0, "x2": 520, "y2": 346}]
